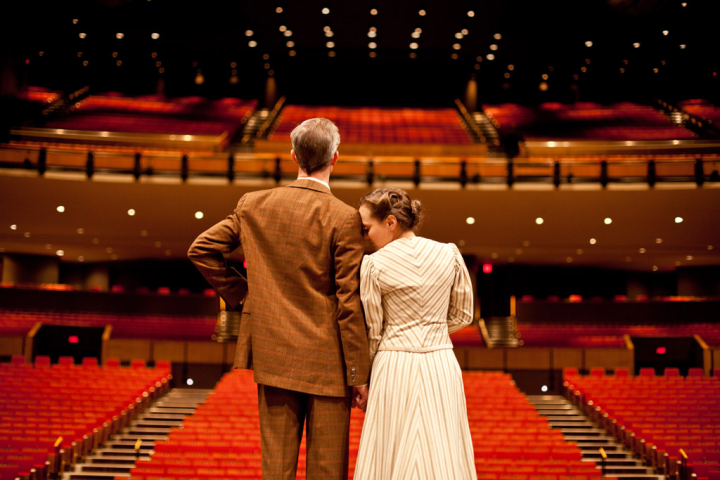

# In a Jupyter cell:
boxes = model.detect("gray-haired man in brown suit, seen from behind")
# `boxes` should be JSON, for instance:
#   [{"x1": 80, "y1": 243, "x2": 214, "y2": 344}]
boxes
[{"x1": 188, "y1": 118, "x2": 370, "y2": 480}]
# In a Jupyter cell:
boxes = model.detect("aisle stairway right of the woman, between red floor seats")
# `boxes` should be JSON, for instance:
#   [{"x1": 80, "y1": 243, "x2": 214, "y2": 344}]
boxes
[{"x1": 528, "y1": 395, "x2": 665, "y2": 480}]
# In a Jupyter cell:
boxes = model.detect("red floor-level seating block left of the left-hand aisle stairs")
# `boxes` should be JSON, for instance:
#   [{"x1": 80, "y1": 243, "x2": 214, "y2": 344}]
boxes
[{"x1": 0, "y1": 356, "x2": 170, "y2": 480}]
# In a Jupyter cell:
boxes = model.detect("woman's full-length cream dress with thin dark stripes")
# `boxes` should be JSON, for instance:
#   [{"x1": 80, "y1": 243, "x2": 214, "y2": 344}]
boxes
[{"x1": 354, "y1": 237, "x2": 477, "y2": 480}]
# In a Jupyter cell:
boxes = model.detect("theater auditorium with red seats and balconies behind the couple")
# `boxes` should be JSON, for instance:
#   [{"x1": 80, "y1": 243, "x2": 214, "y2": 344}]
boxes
[{"x1": 0, "y1": 0, "x2": 720, "y2": 480}]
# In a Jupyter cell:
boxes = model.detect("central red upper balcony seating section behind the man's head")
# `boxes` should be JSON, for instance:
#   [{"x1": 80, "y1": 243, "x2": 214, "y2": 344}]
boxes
[{"x1": 269, "y1": 105, "x2": 472, "y2": 144}]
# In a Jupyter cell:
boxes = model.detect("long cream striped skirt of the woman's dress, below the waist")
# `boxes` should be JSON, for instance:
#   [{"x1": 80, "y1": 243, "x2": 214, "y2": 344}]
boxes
[{"x1": 353, "y1": 349, "x2": 477, "y2": 480}]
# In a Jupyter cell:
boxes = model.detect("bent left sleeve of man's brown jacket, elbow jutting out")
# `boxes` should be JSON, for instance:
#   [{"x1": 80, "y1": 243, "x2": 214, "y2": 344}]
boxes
[{"x1": 188, "y1": 196, "x2": 248, "y2": 308}]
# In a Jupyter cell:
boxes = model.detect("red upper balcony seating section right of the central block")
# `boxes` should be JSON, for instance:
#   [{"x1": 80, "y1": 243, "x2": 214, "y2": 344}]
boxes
[{"x1": 483, "y1": 102, "x2": 696, "y2": 141}]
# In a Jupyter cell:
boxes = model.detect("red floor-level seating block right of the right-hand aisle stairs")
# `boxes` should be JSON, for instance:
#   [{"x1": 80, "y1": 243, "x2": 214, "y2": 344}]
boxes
[{"x1": 564, "y1": 368, "x2": 720, "y2": 479}]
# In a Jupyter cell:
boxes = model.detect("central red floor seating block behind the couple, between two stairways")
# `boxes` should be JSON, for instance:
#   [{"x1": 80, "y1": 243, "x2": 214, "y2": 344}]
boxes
[{"x1": 121, "y1": 370, "x2": 612, "y2": 480}]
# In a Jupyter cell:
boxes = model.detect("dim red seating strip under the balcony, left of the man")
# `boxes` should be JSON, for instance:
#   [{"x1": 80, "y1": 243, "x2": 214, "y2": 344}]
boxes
[{"x1": 0, "y1": 310, "x2": 217, "y2": 340}]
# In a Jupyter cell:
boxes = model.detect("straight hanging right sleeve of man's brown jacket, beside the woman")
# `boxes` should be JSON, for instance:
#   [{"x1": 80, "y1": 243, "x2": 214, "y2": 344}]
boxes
[{"x1": 335, "y1": 211, "x2": 370, "y2": 386}]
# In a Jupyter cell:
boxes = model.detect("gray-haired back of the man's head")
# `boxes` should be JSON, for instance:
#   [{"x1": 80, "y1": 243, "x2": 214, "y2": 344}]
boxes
[{"x1": 290, "y1": 118, "x2": 340, "y2": 175}]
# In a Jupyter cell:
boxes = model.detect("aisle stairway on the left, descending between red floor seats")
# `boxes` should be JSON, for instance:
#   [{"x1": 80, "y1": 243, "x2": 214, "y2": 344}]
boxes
[{"x1": 62, "y1": 388, "x2": 212, "y2": 480}]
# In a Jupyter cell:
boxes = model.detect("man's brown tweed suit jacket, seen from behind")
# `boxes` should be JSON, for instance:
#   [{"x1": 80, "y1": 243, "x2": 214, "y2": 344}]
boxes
[{"x1": 188, "y1": 180, "x2": 370, "y2": 397}]
